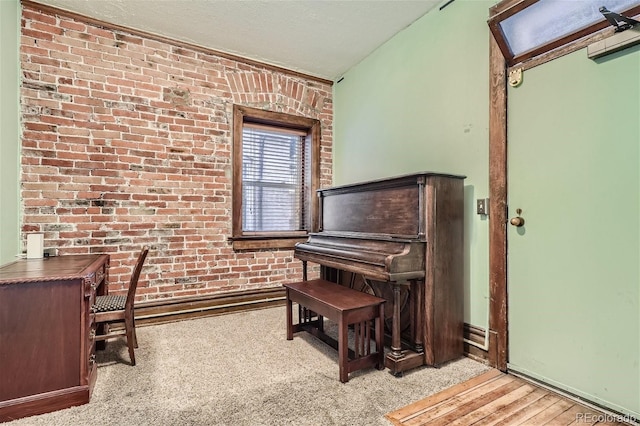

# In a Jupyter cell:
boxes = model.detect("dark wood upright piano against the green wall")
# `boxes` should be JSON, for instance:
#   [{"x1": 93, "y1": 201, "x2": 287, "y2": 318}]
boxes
[{"x1": 295, "y1": 172, "x2": 465, "y2": 374}]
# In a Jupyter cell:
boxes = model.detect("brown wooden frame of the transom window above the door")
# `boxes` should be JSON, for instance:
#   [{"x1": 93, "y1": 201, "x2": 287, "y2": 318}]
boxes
[{"x1": 487, "y1": 0, "x2": 640, "y2": 68}]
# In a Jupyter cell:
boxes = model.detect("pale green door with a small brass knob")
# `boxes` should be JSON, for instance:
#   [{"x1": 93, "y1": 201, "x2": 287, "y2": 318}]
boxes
[{"x1": 507, "y1": 47, "x2": 640, "y2": 417}]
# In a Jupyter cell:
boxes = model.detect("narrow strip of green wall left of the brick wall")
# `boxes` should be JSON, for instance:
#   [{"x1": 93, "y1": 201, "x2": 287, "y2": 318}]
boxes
[{"x1": 0, "y1": 0, "x2": 20, "y2": 265}]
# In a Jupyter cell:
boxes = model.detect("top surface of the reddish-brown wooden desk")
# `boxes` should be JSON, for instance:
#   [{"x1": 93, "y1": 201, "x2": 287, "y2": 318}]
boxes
[{"x1": 0, "y1": 254, "x2": 109, "y2": 284}]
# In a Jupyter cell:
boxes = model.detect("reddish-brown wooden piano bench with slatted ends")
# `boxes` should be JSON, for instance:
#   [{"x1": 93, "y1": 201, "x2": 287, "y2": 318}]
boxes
[{"x1": 284, "y1": 279, "x2": 385, "y2": 383}]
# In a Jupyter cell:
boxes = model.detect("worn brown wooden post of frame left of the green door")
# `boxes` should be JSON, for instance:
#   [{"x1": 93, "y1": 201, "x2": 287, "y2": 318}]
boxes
[{"x1": 487, "y1": 1, "x2": 511, "y2": 371}]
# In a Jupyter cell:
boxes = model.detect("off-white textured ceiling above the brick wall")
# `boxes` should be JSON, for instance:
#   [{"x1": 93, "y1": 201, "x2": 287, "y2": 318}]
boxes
[{"x1": 36, "y1": 0, "x2": 442, "y2": 80}]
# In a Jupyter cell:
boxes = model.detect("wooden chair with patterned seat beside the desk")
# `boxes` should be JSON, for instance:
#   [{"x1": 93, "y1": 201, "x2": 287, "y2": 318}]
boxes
[{"x1": 93, "y1": 246, "x2": 149, "y2": 365}]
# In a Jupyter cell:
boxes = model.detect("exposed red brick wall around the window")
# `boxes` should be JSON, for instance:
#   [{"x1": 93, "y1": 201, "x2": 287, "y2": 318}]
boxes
[{"x1": 20, "y1": 7, "x2": 333, "y2": 301}]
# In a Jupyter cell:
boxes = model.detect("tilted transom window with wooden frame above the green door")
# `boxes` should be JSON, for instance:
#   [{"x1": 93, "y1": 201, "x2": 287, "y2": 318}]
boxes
[{"x1": 489, "y1": 0, "x2": 640, "y2": 66}]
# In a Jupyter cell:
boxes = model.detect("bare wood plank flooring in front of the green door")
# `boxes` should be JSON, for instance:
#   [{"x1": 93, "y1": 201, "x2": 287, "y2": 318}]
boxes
[{"x1": 385, "y1": 370, "x2": 625, "y2": 426}]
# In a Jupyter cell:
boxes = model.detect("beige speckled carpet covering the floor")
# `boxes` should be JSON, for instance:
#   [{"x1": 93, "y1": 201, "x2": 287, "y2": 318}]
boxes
[{"x1": 5, "y1": 307, "x2": 488, "y2": 426}]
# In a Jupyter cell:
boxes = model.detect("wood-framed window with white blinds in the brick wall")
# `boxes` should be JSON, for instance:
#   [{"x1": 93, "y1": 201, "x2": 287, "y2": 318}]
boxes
[{"x1": 232, "y1": 105, "x2": 320, "y2": 249}]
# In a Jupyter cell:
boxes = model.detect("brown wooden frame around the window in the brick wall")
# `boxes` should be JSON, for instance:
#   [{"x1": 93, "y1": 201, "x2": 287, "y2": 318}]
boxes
[{"x1": 231, "y1": 105, "x2": 320, "y2": 250}]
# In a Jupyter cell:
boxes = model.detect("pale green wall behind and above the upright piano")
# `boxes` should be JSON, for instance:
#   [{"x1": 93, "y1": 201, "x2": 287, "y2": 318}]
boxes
[{"x1": 334, "y1": 0, "x2": 495, "y2": 328}]
